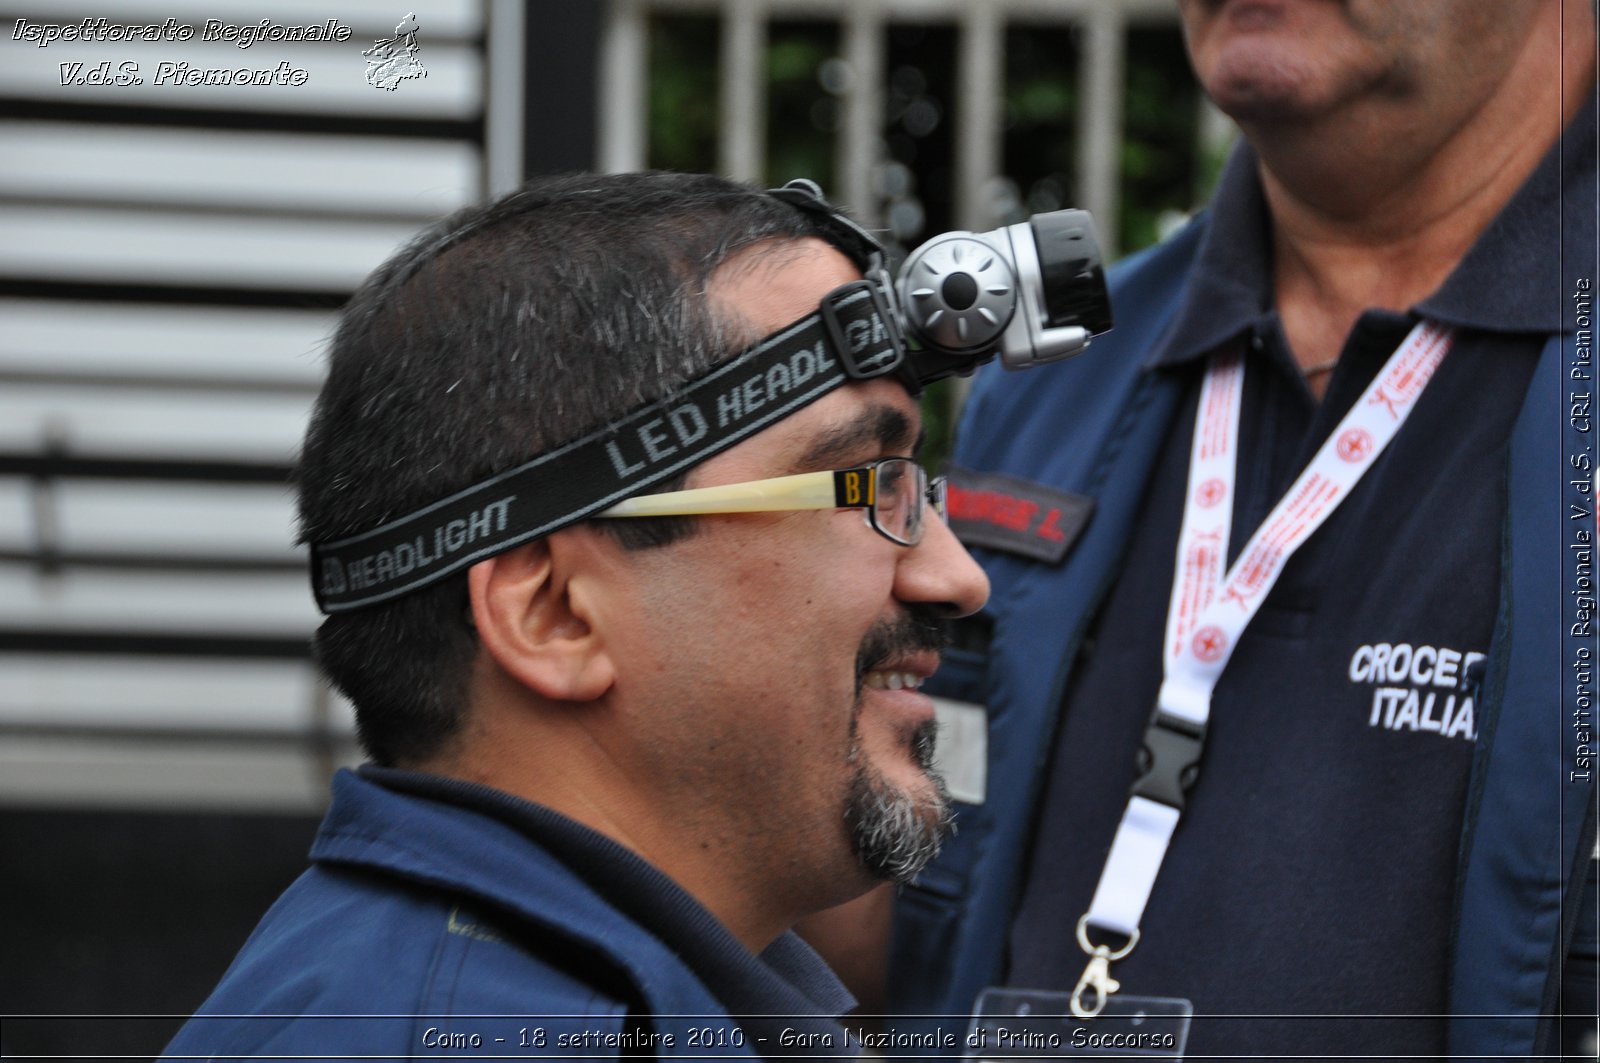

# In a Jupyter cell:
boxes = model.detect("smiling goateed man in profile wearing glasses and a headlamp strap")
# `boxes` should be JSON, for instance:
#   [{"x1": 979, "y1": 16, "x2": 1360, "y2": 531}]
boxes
[{"x1": 170, "y1": 174, "x2": 987, "y2": 1057}]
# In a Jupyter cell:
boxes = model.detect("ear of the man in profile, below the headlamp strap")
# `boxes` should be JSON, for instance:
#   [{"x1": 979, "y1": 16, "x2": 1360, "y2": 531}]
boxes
[{"x1": 467, "y1": 535, "x2": 616, "y2": 701}]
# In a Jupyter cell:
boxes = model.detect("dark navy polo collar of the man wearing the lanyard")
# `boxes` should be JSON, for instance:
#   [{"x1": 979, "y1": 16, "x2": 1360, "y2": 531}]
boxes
[{"x1": 1146, "y1": 83, "x2": 1597, "y2": 367}]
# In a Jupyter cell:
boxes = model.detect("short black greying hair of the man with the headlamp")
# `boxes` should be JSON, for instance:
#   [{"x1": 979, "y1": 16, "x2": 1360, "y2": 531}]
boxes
[{"x1": 298, "y1": 173, "x2": 851, "y2": 765}]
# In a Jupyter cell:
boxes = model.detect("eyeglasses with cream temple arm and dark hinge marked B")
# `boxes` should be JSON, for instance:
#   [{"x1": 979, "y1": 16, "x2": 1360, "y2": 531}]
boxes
[{"x1": 595, "y1": 458, "x2": 944, "y2": 546}]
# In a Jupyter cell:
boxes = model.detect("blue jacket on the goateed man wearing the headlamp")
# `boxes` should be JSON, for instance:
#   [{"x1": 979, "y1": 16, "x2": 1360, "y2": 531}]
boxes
[{"x1": 166, "y1": 772, "x2": 842, "y2": 1058}]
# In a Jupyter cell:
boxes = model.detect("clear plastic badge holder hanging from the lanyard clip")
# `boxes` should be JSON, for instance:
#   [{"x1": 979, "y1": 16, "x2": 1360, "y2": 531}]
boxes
[{"x1": 965, "y1": 986, "x2": 1195, "y2": 1063}]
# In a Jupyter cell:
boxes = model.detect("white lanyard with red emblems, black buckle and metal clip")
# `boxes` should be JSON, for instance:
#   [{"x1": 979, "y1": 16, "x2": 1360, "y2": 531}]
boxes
[{"x1": 1072, "y1": 322, "x2": 1454, "y2": 1018}]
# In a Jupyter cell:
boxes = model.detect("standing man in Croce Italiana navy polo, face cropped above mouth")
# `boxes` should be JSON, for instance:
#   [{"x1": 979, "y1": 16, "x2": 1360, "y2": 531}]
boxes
[{"x1": 890, "y1": 0, "x2": 1597, "y2": 1058}]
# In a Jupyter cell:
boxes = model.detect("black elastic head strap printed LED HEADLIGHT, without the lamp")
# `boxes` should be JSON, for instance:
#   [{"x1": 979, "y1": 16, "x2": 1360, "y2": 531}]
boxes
[{"x1": 310, "y1": 280, "x2": 904, "y2": 613}]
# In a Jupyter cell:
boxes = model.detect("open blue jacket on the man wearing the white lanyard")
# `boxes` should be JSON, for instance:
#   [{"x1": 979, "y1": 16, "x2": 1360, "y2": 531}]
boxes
[{"x1": 890, "y1": 192, "x2": 1595, "y2": 1057}]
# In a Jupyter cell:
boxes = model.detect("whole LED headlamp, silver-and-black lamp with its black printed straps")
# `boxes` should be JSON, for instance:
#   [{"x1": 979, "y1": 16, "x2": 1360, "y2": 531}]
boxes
[{"x1": 310, "y1": 181, "x2": 1110, "y2": 613}]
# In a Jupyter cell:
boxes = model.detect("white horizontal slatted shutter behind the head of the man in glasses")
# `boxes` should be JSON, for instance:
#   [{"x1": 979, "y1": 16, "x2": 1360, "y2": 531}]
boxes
[{"x1": 0, "y1": 0, "x2": 489, "y2": 808}]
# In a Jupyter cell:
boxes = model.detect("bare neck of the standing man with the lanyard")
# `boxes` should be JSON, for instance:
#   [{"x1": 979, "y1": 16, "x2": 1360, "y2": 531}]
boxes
[{"x1": 1248, "y1": 6, "x2": 1595, "y2": 389}]
